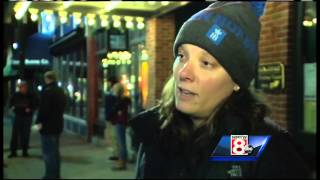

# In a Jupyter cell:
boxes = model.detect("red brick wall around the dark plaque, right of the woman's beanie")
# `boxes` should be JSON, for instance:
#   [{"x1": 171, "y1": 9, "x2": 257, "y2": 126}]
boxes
[{"x1": 259, "y1": 2, "x2": 296, "y2": 128}]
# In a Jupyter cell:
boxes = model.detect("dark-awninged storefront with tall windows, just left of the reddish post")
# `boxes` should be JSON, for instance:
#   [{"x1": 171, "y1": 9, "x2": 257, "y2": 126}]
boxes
[{"x1": 50, "y1": 27, "x2": 88, "y2": 137}]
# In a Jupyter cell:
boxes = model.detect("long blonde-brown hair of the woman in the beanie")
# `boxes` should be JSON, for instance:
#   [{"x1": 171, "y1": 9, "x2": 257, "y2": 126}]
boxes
[{"x1": 159, "y1": 76, "x2": 269, "y2": 160}]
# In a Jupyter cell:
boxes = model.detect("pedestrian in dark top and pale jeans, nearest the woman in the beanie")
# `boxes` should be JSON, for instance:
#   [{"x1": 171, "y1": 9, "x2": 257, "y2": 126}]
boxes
[{"x1": 111, "y1": 82, "x2": 131, "y2": 171}]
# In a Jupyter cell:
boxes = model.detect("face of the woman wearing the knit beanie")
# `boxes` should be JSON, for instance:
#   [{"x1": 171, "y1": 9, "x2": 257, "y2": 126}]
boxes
[{"x1": 173, "y1": 44, "x2": 236, "y2": 118}]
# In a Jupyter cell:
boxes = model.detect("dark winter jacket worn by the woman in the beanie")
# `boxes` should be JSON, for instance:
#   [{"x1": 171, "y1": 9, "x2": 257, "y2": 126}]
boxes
[{"x1": 129, "y1": 109, "x2": 310, "y2": 179}]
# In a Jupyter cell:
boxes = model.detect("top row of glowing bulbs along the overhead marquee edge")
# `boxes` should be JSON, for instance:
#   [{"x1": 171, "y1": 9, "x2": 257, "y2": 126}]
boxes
[{"x1": 19, "y1": 8, "x2": 145, "y2": 29}]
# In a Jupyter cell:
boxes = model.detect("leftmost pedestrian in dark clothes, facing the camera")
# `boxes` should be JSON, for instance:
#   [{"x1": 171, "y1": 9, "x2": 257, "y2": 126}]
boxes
[{"x1": 8, "y1": 81, "x2": 37, "y2": 158}]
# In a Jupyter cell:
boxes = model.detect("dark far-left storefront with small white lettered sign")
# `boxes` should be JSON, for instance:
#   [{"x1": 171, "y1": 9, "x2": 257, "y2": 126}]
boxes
[{"x1": 4, "y1": 33, "x2": 52, "y2": 104}]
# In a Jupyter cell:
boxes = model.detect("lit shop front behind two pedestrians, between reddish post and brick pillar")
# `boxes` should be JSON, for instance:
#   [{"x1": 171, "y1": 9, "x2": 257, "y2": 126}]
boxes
[{"x1": 94, "y1": 27, "x2": 145, "y2": 135}]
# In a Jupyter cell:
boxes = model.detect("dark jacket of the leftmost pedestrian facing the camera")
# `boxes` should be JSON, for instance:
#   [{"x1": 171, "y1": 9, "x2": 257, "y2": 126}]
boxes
[{"x1": 9, "y1": 92, "x2": 38, "y2": 117}]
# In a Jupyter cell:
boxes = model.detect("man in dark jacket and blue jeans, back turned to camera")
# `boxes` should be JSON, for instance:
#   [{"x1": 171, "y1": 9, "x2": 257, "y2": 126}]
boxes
[{"x1": 36, "y1": 71, "x2": 66, "y2": 179}]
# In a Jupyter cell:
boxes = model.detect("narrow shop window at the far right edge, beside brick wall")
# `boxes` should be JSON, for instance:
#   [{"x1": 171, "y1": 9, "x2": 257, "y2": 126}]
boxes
[{"x1": 302, "y1": 2, "x2": 317, "y2": 133}]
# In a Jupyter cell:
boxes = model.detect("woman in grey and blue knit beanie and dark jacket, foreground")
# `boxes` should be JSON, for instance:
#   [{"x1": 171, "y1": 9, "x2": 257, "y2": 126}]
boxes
[{"x1": 129, "y1": 2, "x2": 308, "y2": 178}]
